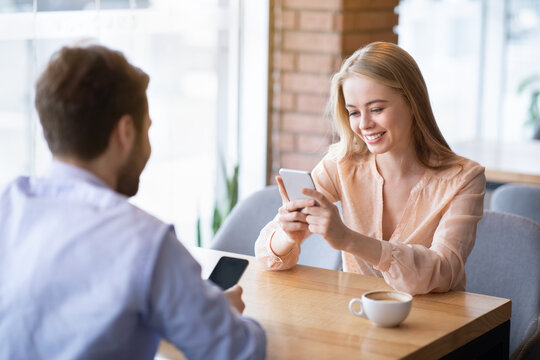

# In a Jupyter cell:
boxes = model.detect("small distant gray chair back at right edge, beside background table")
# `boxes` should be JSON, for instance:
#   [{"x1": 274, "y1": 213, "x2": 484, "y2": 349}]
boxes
[{"x1": 490, "y1": 183, "x2": 540, "y2": 224}]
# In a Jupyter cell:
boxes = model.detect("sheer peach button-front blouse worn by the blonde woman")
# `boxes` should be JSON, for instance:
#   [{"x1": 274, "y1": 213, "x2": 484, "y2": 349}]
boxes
[{"x1": 255, "y1": 154, "x2": 486, "y2": 295}]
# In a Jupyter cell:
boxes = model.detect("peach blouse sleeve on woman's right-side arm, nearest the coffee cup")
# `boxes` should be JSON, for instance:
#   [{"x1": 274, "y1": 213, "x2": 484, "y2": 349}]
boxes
[{"x1": 375, "y1": 166, "x2": 486, "y2": 295}]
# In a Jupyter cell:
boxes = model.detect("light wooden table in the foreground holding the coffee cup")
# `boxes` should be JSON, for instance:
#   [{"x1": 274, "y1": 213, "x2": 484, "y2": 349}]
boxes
[{"x1": 158, "y1": 248, "x2": 511, "y2": 360}]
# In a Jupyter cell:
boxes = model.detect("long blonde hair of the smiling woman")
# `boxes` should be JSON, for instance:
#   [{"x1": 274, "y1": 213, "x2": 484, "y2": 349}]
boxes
[{"x1": 329, "y1": 42, "x2": 456, "y2": 169}]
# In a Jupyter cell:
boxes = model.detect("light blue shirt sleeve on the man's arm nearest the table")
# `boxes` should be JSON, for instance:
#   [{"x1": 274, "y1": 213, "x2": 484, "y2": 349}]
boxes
[{"x1": 148, "y1": 229, "x2": 266, "y2": 359}]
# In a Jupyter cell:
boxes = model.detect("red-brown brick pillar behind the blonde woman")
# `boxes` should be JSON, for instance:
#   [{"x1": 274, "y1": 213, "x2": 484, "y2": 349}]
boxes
[{"x1": 267, "y1": 0, "x2": 399, "y2": 184}]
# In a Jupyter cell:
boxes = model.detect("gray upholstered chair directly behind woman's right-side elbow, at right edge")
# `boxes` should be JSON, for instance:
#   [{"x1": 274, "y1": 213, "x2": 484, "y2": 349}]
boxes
[{"x1": 465, "y1": 211, "x2": 540, "y2": 359}]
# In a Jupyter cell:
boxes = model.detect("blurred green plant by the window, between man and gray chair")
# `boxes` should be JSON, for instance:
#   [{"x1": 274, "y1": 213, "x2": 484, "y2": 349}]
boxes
[{"x1": 193, "y1": 159, "x2": 239, "y2": 247}]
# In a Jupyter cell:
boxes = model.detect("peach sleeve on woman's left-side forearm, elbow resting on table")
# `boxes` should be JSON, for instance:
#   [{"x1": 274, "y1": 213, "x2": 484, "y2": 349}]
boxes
[{"x1": 255, "y1": 219, "x2": 300, "y2": 270}]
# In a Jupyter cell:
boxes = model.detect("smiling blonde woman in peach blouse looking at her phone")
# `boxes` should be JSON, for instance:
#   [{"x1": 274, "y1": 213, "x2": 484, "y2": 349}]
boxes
[{"x1": 255, "y1": 42, "x2": 486, "y2": 294}]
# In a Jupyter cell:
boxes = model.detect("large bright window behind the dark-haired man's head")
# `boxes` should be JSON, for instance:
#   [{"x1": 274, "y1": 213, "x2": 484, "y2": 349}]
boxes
[{"x1": 0, "y1": 0, "x2": 267, "y2": 244}]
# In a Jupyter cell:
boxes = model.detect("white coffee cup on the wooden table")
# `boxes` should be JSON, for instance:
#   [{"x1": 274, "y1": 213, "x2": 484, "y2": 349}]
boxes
[{"x1": 349, "y1": 290, "x2": 413, "y2": 327}]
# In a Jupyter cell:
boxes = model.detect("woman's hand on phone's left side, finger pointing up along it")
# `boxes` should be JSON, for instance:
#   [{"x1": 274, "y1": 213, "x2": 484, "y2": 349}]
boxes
[{"x1": 276, "y1": 176, "x2": 316, "y2": 244}]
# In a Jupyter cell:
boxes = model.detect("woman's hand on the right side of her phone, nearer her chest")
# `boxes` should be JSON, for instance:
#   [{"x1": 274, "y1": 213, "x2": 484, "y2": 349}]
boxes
[{"x1": 302, "y1": 189, "x2": 351, "y2": 250}]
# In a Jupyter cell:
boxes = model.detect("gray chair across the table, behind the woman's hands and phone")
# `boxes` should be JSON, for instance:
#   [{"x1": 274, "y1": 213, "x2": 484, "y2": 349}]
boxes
[{"x1": 210, "y1": 186, "x2": 341, "y2": 270}]
